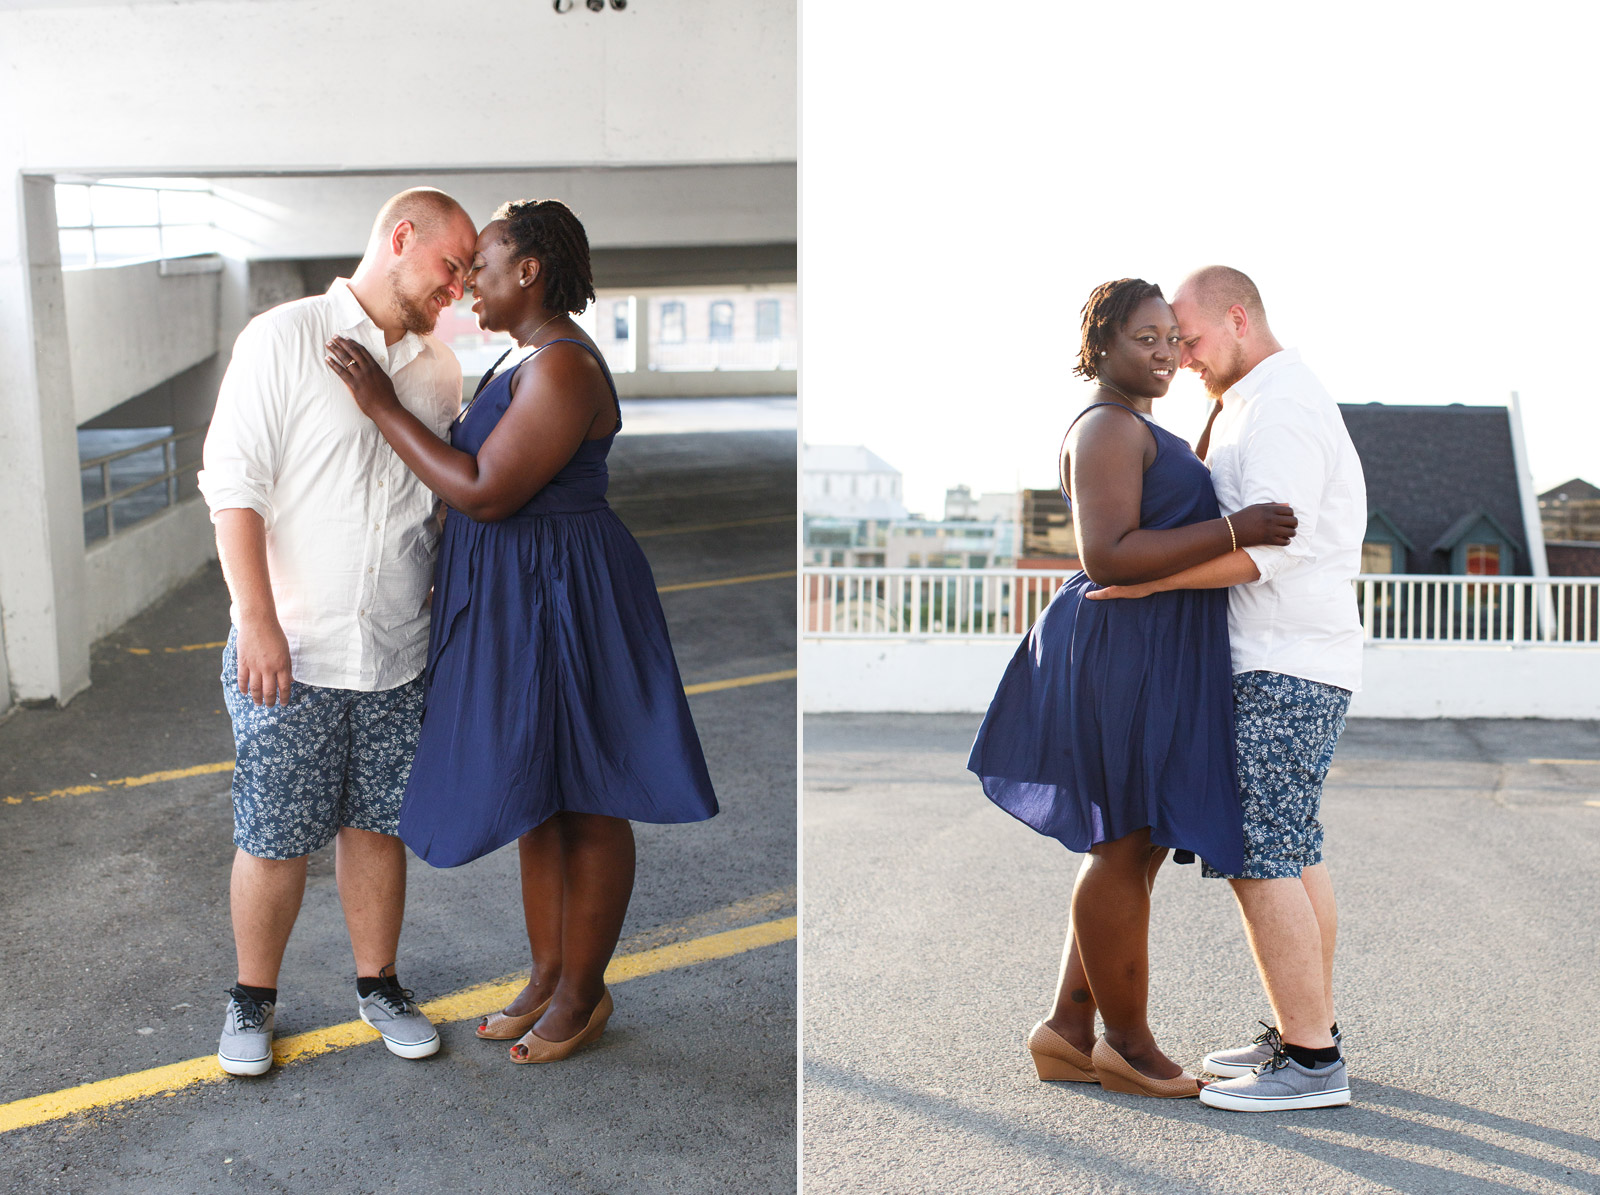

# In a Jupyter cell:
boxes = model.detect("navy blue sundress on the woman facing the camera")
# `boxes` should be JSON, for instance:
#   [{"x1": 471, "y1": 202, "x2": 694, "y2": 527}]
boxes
[{"x1": 966, "y1": 403, "x2": 1245, "y2": 873}]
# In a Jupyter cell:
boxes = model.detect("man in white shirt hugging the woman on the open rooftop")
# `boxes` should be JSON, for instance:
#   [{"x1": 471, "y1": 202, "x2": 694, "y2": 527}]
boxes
[{"x1": 1093, "y1": 266, "x2": 1366, "y2": 1112}]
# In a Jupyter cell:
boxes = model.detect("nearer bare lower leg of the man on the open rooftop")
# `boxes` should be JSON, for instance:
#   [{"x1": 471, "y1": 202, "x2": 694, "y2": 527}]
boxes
[{"x1": 1229, "y1": 877, "x2": 1333, "y2": 1049}]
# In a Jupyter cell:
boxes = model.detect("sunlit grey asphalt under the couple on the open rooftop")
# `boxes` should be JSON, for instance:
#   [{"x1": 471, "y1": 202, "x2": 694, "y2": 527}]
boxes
[{"x1": 802, "y1": 715, "x2": 1600, "y2": 1195}]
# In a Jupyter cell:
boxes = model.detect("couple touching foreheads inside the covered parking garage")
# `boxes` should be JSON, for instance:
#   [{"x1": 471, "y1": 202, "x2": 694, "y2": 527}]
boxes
[{"x1": 200, "y1": 187, "x2": 717, "y2": 1075}]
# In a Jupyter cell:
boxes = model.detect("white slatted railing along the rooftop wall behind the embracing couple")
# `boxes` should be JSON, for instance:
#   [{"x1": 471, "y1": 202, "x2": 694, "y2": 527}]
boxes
[{"x1": 800, "y1": 568, "x2": 1600, "y2": 646}]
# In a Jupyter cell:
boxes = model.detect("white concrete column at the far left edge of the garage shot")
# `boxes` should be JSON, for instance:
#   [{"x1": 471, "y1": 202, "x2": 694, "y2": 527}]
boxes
[{"x1": 0, "y1": 171, "x2": 90, "y2": 704}]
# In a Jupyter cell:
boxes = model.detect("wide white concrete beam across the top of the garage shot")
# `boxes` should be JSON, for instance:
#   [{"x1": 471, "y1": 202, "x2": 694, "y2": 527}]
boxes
[{"x1": 0, "y1": 0, "x2": 798, "y2": 172}]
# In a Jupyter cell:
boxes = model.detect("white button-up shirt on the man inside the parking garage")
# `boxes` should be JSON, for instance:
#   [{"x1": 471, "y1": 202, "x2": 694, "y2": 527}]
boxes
[{"x1": 200, "y1": 278, "x2": 461, "y2": 693}]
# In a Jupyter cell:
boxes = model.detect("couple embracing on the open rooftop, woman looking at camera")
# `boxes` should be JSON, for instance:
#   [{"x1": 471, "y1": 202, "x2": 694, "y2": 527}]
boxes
[{"x1": 968, "y1": 266, "x2": 1366, "y2": 1112}]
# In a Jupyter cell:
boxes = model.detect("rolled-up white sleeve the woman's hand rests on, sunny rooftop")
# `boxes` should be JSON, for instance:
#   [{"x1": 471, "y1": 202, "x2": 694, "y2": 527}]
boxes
[{"x1": 1240, "y1": 402, "x2": 1333, "y2": 586}]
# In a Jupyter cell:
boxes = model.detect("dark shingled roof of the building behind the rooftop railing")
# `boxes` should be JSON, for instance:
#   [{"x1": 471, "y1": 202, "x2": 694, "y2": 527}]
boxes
[{"x1": 1339, "y1": 403, "x2": 1530, "y2": 574}]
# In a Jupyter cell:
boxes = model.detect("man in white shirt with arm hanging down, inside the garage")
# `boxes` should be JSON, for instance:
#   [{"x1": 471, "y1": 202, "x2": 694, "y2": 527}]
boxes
[{"x1": 200, "y1": 187, "x2": 477, "y2": 1075}]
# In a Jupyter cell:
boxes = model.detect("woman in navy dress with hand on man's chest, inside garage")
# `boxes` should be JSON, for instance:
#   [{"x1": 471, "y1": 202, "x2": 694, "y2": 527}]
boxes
[{"x1": 328, "y1": 200, "x2": 717, "y2": 1062}]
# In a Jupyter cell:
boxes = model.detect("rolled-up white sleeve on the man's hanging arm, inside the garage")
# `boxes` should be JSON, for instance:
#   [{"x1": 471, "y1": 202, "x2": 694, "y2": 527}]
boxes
[{"x1": 197, "y1": 317, "x2": 285, "y2": 528}]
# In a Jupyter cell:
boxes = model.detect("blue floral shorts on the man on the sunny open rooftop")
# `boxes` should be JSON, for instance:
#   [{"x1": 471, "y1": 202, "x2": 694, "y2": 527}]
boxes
[{"x1": 1202, "y1": 672, "x2": 1350, "y2": 880}]
